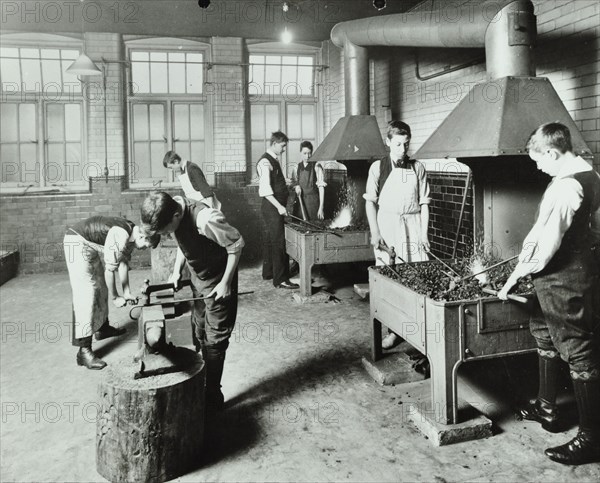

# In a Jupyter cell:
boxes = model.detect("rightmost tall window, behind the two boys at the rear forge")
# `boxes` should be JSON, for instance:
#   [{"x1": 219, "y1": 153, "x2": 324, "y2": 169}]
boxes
[{"x1": 248, "y1": 53, "x2": 317, "y2": 178}]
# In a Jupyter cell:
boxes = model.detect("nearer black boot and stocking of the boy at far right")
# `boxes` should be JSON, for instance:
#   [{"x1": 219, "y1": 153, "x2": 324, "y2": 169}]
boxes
[{"x1": 545, "y1": 379, "x2": 600, "y2": 465}]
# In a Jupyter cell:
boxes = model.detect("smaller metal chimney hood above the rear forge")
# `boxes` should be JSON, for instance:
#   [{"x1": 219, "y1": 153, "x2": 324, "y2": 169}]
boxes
[{"x1": 311, "y1": 115, "x2": 387, "y2": 161}]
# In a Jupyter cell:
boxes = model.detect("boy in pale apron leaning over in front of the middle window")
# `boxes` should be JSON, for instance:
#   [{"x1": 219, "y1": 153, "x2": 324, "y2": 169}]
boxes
[{"x1": 163, "y1": 151, "x2": 221, "y2": 210}]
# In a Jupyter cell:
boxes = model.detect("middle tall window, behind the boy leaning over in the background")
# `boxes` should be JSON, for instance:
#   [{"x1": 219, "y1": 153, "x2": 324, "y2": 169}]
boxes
[{"x1": 129, "y1": 42, "x2": 214, "y2": 186}]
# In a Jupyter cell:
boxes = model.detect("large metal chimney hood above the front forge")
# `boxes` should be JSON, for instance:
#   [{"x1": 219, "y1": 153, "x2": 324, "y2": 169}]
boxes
[{"x1": 415, "y1": 76, "x2": 592, "y2": 159}]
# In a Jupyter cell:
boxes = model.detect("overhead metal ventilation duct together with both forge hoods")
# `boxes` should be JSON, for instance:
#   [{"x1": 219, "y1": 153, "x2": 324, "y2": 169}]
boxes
[{"x1": 313, "y1": 0, "x2": 591, "y2": 161}]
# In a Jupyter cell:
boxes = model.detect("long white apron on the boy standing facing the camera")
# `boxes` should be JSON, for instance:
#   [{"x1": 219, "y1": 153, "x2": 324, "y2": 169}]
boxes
[{"x1": 375, "y1": 165, "x2": 429, "y2": 265}]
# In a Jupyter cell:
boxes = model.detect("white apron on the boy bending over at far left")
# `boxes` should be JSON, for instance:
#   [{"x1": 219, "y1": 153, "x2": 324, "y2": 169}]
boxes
[{"x1": 63, "y1": 234, "x2": 108, "y2": 339}]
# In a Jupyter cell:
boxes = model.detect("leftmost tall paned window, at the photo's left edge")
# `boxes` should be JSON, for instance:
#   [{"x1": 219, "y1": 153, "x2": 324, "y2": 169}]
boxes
[{"x1": 0, "y1": 36, "x2": 87, "y2": 192}]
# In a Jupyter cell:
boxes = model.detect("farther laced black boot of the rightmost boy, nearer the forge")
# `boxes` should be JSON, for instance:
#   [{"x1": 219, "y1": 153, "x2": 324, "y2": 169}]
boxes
[{"x1": 518, "y1": 356, "x2": 561, "y2": 433}]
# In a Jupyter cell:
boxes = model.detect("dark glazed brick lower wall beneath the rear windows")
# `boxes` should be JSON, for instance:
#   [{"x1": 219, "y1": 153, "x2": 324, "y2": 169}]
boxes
[{"x1": 0, "y1": 170, "x2": 352, "y2": 273}]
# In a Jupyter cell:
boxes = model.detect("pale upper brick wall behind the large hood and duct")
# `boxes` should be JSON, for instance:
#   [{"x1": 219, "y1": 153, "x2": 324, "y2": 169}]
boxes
[{"x1": 391, "y1": 0, "x2": 600, "y2": 169}]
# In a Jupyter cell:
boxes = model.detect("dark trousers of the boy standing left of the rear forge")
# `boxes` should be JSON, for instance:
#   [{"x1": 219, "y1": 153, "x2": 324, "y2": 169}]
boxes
[{"x1": 261, "y1": 198, "x2": 290, "y2": 286}]
